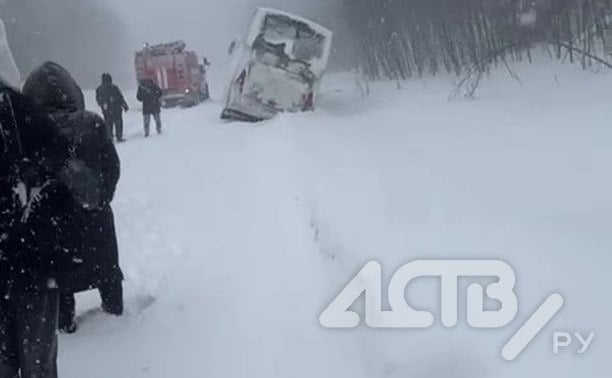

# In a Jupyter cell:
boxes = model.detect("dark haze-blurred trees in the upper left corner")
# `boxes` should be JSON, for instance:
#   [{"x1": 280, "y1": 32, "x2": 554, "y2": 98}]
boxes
[{"x1": 0, "y1": 0, "x2": 124, "y2": 87}]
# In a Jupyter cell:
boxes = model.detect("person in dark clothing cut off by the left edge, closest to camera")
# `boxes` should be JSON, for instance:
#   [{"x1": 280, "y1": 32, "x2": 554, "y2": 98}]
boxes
[{"x1": 0, "y1": 71, "x2": 99, "y2": 378}]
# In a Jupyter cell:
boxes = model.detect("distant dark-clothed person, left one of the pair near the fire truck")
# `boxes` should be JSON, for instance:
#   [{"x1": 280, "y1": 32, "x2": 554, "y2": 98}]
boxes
[{"x1": 96, "y1": 73, "x2": 129, "y2": 142}]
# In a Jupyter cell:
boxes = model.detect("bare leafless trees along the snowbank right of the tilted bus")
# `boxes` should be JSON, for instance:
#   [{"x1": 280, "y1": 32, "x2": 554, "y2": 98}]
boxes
[{"x1": 344, "y1": 0, "x2": 612, "y2": 79}]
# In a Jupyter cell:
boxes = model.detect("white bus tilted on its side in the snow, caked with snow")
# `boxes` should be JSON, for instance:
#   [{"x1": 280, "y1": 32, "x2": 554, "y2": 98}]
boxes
[{"x1": 221, "y1": 8, "x2": 332, "y2": 122}]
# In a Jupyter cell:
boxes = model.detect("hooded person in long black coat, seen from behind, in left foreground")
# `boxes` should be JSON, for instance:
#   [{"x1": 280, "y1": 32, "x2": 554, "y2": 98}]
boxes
[{"x1": 23, "y1": 62, "x2": 123, "y2": 332}]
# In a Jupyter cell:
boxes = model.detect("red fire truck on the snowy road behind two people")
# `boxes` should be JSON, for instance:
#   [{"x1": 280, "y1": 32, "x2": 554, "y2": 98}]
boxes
[{"x1": 135, "y1": 41, "x2": 210, "y2": 107}]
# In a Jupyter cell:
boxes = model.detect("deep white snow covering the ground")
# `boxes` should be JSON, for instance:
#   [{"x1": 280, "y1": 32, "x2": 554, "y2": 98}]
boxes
[{"x1": 60, "y1": 57, "x2": 612, "y2": 378}]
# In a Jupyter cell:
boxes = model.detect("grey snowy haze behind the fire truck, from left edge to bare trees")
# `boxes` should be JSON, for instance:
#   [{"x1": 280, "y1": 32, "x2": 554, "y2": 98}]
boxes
[{"x1": 0, "y1": 0, "x2": 342, "y2": 88}]
